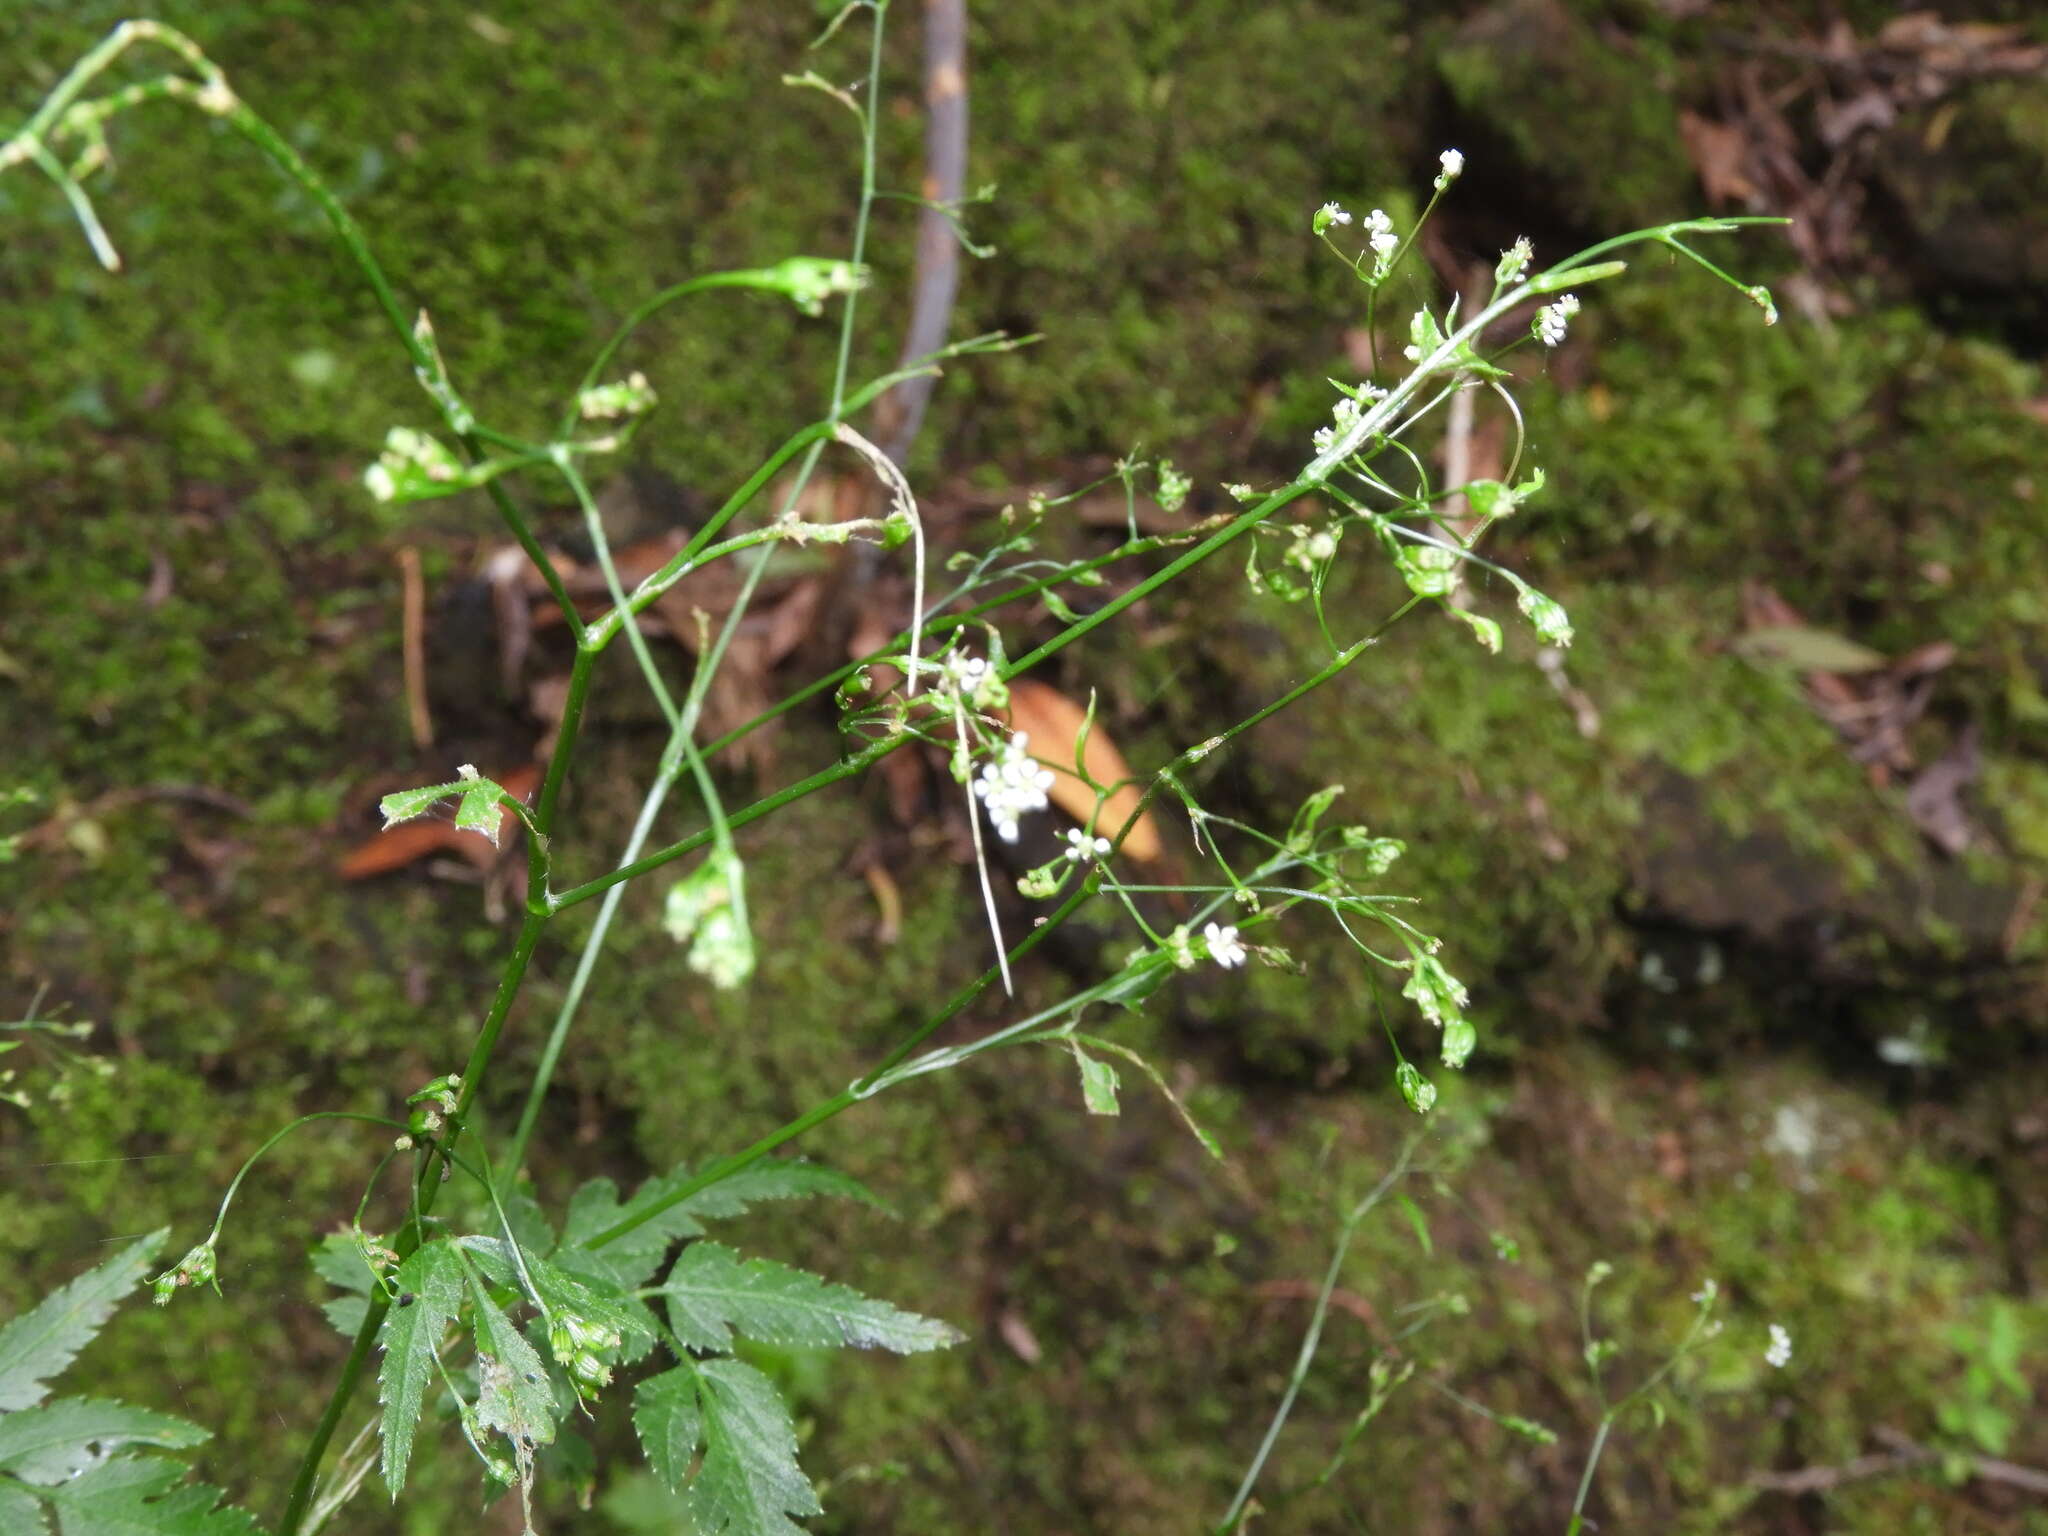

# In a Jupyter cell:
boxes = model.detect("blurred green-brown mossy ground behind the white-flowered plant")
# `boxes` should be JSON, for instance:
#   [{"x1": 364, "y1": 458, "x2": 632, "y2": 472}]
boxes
[{"x1": 0, "y1": 0, "x2": 2048, "y2": 1534}]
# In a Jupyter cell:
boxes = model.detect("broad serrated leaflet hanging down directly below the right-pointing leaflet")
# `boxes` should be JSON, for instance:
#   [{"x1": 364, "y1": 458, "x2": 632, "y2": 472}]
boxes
[{"x1": 688, "y1": 1360, "x2": 823, "y2": 1536}]
